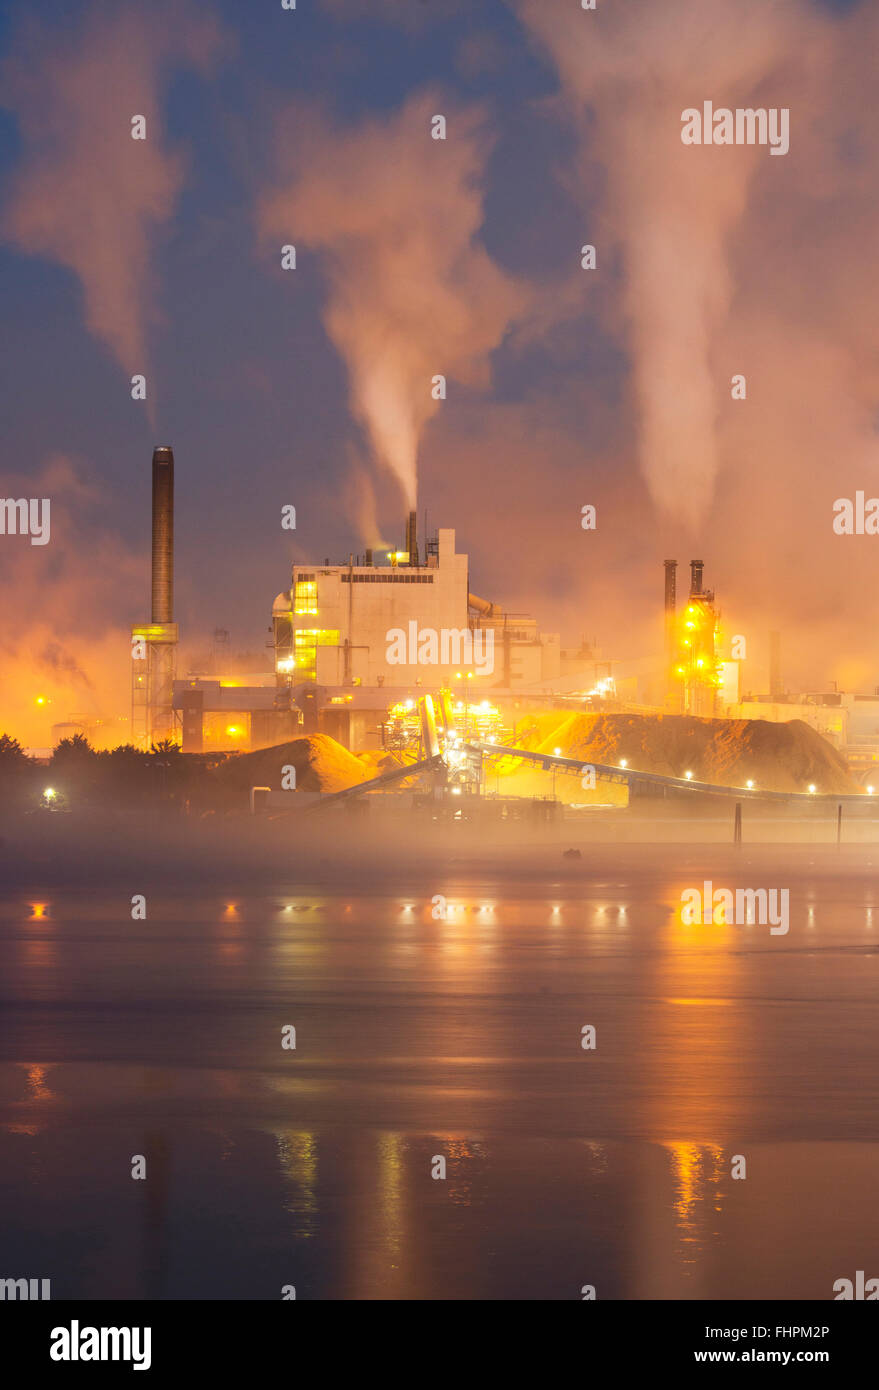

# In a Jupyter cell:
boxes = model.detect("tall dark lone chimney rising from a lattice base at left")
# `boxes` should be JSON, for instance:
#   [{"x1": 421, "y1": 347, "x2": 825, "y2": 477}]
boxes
[{"x1": 131, "y1": 445, "x2": 177, "y2": 748}]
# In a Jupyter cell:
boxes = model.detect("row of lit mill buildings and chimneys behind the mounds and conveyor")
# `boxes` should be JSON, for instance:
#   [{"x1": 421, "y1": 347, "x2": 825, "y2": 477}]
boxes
[{"x1": 121, "y1": 458, "x2": 879, "y2": 784}]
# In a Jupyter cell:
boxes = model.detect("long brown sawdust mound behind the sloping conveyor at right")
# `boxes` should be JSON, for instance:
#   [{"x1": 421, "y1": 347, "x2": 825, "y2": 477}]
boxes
[{"x1": 516, "y1": 713, "x2": 858, "y2": 792}]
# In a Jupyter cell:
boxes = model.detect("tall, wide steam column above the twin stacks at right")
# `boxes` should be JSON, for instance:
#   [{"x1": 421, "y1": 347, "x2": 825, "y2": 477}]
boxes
[{"x1": 520, "y1": 0, "x2": 841, "y2": 527}]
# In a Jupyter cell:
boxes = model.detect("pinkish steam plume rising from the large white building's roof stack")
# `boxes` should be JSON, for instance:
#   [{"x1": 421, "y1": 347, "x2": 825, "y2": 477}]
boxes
[{"x1": 259, "y1": 93, "x2": 526, "y2": 519}]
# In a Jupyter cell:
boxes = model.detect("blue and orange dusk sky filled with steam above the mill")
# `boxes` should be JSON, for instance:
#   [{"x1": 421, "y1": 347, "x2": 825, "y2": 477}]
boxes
[{"x1": 0, "y1": 0, "x2": 879, "y2": 742}]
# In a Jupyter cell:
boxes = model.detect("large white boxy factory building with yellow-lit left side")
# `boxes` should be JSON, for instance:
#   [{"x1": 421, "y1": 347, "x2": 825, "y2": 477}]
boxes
[{"x1": 273, "y1": 516, "x2": 561, "y2": 692}]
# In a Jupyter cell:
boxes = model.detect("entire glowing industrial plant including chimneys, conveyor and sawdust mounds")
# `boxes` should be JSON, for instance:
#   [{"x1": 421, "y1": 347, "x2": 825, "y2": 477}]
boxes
[{"x1": 65, "y1": 445, "x2": 879, "y2": 815}]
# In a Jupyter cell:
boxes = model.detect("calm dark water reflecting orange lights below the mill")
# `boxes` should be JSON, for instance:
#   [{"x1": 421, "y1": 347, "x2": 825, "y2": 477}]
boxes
[{"x1": 0, "y1": 848, "x2": 879, "y2": 1298}]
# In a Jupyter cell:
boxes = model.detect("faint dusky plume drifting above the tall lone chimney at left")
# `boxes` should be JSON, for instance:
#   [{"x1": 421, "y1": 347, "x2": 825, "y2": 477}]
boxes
[{"x1": 3, "y1": 3, "x2": 226, "y2": 374}]
